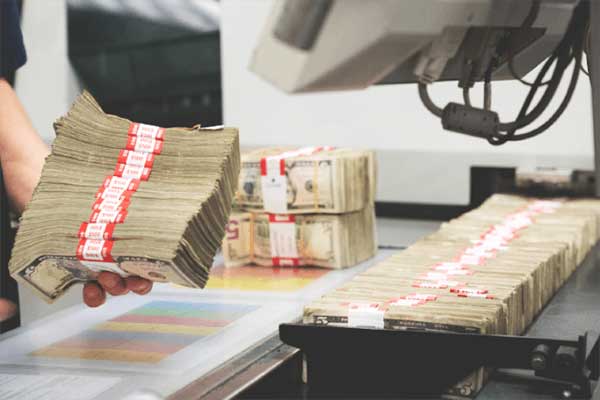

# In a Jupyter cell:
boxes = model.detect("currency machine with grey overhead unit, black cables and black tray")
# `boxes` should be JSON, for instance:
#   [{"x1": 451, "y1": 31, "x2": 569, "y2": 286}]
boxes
[{"x1": 240, "y1": 0, "x2": 600, "y2": 399}]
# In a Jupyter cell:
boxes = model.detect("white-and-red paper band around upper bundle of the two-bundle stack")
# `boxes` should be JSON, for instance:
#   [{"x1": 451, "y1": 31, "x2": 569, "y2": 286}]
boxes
[{"x1": 260, "y1": 146, "x2": 333, "y2": 214}]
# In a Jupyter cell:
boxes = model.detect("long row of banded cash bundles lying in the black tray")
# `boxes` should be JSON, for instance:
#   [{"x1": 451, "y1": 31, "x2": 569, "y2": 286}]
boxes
[{"x1": 304, "y1": 195, "x2": 600, "y2": 395}]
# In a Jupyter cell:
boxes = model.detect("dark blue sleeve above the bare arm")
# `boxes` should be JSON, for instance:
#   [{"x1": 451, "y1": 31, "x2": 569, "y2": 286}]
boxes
[{"x1": 0, "y1": 0, "x2": 27, "y2": 77}]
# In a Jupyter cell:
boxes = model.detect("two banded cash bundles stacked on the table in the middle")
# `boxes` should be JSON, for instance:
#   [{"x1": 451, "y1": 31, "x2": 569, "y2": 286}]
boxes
[{"x1": 223, "y1": 146, "x2": 377, "y2": 268}]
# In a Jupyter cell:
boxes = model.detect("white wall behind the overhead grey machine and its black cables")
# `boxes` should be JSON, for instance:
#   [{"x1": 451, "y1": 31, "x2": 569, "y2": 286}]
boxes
[{"x1": 221, "y1": 0, "x2": 593, "y2": 204}]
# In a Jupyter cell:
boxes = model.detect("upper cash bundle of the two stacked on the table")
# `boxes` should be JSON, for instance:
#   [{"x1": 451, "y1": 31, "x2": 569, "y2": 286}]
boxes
[{"x1": 235, "y1": 146, "x2": 376, "y2": 214}]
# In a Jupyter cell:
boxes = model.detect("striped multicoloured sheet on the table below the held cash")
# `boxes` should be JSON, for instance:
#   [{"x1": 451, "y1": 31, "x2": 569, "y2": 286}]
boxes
[{"x1": 31, "y1": 301, "x2": 257, "y2": 364}]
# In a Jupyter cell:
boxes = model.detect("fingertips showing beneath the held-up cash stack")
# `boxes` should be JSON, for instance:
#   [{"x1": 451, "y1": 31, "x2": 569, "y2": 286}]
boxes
[{"x1": 83, "y1": 272, "x2": 152, "y2": 307}]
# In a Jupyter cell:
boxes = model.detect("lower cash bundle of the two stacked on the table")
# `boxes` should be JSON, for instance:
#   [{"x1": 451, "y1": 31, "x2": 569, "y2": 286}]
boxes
[{"x1": 223, "y1": 206, "x2": 377, "y2": 268}]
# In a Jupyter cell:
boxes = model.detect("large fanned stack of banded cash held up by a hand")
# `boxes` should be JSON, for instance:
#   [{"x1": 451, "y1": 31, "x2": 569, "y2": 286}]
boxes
[{"x1": 10, "y1": 93, "x2": 240, "y2": 302}]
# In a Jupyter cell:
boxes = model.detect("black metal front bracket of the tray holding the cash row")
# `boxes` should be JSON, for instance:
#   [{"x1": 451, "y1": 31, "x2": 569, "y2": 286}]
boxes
[{"x1": 279, "y1": 324, "x2": 600, "y2": 398}]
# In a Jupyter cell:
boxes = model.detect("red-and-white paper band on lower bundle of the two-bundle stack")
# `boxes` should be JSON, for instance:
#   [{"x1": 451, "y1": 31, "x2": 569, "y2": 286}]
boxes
[{"x1": 269, "y1": 214, "x2": 300, "y2": 267}]
